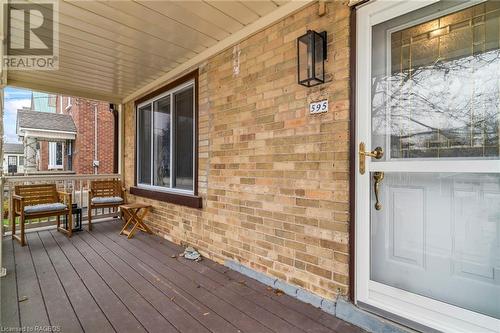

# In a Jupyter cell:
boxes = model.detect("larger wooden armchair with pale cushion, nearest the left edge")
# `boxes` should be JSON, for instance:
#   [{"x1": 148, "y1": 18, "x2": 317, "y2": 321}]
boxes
[{"x1": 10, "y1": 184, "x2": 73, "y2": 246}]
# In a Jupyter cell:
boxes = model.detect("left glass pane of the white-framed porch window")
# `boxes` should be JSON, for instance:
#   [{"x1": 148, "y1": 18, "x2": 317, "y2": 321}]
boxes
[{"x1": 137, "y1": 104, "x2": 151, "y2": 185}]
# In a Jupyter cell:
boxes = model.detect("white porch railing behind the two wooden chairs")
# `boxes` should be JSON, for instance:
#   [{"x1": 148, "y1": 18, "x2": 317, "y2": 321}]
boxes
[{"x1": 0, "y1": 174, "x2": 121, "y2": 234}]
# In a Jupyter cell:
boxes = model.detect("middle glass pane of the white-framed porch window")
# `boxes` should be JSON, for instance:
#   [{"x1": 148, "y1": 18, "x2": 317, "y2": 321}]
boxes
[{"x1": 153, "y1": 96, "x2": 171, "y2": 187}]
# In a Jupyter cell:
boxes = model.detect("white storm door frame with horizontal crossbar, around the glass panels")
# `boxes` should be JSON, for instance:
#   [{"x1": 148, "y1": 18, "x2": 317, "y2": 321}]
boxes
[{"x1": 353, "y1": 0, "x2": 500, "y2": 333}]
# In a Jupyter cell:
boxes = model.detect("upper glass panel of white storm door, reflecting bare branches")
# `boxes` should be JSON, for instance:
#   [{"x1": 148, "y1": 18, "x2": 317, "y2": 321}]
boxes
[{"x1": 372, "y1": 1, "x2": 500, "y2": 162}]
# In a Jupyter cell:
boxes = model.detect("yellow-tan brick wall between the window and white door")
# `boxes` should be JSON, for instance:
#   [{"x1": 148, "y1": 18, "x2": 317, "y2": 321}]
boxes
[{"x1": 124, "y1": 2, "x2": 349, "y2": 298}]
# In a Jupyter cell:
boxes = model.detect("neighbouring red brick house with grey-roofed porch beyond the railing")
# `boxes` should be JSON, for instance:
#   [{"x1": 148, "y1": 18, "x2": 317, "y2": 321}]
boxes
[{"x1": 14, "y1": 92, "x2": 115, "y2": 174}]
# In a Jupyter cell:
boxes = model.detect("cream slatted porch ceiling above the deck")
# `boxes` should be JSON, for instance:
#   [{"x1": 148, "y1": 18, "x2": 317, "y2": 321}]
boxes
[{"x1": 7, "y1": 0, "x2": 310, "y2": 102}]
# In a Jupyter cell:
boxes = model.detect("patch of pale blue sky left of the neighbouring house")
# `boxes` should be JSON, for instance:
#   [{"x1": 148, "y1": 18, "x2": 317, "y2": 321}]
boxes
[{"x1": 3, "y1": 87, "x2": 31, "y2": 143}]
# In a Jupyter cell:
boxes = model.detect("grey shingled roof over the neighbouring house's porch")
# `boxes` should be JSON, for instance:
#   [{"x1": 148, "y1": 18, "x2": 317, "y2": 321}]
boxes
[{"x1": 17, "y1": 110, "x2": 76, "y2": 134}]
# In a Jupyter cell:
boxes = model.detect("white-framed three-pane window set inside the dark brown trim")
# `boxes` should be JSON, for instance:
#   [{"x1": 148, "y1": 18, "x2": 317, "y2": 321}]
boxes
[{"x1": 137, "y1": 81, "x2": 196, "y2": 194}]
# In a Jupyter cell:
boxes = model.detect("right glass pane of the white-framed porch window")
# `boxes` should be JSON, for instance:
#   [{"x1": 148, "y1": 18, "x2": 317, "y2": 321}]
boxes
[{"x1": 173, "y1": 86, "x2": 194, "y2": 191}]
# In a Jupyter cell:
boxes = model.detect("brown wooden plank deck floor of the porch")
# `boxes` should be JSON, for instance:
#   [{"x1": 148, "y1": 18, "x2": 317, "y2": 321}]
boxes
[{"x1": 1, "y1": 221, "x2": 362, "y2": 333}]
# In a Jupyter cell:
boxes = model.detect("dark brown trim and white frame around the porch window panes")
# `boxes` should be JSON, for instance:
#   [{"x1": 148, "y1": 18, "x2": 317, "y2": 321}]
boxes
[{"x1": 134, "y1": 69, "x2": 202, "y2": 208}]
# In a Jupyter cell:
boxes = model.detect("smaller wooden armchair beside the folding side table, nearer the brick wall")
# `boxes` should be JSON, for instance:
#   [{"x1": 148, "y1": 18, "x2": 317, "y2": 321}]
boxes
[{"x1": 87, "y1": 179, "x2": 125, "y2": 231}]
